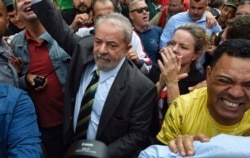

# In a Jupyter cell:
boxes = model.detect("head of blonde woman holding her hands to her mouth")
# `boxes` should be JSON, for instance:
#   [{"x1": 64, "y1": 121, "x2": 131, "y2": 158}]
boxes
[{"x1": 168, "y1": 24, "x2": 209, "y2": 69}]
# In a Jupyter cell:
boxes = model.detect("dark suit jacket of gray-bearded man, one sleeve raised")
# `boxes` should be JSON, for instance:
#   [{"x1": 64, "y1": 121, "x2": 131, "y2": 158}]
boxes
[{"x1": 32, "y1": 0, "x2": 157, "y2": 158}]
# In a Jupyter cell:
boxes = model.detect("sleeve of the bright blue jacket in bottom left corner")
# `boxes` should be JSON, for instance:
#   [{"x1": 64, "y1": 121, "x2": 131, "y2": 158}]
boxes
[{"x1": 8, "y1": 87, "x2": 42, "y2": 158}]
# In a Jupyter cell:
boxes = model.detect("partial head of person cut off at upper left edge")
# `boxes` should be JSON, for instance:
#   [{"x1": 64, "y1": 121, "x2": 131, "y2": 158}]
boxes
[{"x1": 0, "y1": 0, "x2": 8, "y2": 40}]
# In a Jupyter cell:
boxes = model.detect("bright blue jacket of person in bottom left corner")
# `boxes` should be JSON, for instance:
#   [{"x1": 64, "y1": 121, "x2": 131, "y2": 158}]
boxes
[{"x1": 0, "y1": 83, "x2": 42, "y2": 158}]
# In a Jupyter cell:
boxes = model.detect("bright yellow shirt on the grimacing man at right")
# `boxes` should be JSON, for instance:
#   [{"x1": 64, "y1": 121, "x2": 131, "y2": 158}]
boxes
[{"x1": 157, "y1": 88, "x2": 250, "y2": 144}]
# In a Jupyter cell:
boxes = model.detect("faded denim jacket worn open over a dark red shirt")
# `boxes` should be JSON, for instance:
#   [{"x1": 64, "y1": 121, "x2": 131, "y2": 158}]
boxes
[{"x1": 11, "y1": 31, "x2": 71, "y2": 89}]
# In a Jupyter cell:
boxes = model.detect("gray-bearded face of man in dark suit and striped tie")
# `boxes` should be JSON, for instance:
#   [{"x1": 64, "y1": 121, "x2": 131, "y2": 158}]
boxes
[{"x1": 94, "y1": 21, "x2": 129, "y2": 71}]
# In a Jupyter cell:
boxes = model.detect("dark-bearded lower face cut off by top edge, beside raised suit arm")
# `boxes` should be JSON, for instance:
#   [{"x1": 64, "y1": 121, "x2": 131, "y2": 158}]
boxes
[{"x1": 72, "y1": 0, "x2": 91, "y2": 13}]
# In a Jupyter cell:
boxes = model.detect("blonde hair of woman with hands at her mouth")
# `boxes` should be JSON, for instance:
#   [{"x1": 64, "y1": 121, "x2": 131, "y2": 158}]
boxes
[{"x1": 176, "y1": 23, "x2": 209, "y2": 52}]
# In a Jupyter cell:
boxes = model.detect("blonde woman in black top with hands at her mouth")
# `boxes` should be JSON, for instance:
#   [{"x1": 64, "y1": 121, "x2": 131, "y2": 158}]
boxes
[{"x1": 149, "y1": 24, "x2": 209, "y2": 136}]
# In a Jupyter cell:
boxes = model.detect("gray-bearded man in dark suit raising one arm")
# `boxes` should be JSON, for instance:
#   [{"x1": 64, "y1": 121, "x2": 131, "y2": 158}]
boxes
[{"x1": 32, "y1": 0, "x2": 156, "y2": 158}]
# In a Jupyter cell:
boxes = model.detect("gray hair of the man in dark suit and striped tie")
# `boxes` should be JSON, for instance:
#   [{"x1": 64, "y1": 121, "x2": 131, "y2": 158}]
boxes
[{"x1": 95, "y1": 13, "x2": 133, "y2": 44}]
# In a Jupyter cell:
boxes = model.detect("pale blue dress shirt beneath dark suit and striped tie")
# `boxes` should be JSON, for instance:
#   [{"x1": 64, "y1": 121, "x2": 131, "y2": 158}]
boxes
[{"x1": 73, "y1": 58, "x2": 125, "y2": 140}]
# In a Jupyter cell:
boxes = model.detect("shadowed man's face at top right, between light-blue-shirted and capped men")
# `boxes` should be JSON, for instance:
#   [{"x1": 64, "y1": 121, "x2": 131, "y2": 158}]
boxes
[{"x1": 219, "y1": 5, "x2": 236, "y2": 23}]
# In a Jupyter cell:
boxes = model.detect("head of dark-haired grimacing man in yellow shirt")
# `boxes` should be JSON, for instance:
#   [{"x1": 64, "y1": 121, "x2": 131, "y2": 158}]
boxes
[{"x1": 206, "y1": 39, "x2": 250, "y2": 125}]
